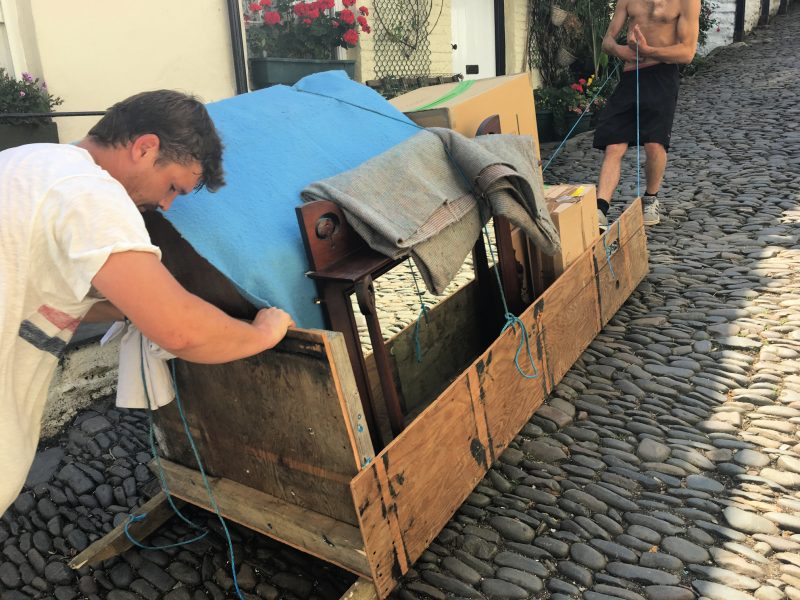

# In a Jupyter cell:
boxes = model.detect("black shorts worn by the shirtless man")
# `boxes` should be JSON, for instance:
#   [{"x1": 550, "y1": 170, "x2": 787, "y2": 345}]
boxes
[{"x1": 594, "y1": 63, "x2": 680, "y2": 150}]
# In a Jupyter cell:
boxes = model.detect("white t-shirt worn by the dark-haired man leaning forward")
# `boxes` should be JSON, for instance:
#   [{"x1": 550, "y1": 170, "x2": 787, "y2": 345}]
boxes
[{"x1": 0, "y1": 144, "x2": 161, "y2": 514}]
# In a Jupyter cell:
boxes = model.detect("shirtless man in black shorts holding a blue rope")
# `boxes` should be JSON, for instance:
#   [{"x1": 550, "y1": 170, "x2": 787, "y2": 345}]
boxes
[{"x1": 594, "y1": 0, "x2": 700, "y2": 229}]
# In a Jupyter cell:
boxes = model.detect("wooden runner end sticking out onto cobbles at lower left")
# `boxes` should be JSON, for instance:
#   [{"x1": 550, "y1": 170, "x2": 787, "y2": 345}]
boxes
[{"x1": 69, "y1": 491, "x2": 183, "y2": 569}]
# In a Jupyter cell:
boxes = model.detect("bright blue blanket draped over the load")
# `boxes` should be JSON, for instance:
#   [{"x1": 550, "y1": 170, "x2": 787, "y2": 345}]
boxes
[{"x1": 165, "y1": 71, "x2": 418, "y2": 327}]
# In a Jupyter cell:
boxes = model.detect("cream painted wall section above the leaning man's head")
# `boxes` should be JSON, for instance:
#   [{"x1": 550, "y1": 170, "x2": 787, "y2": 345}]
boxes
[{"x1": 14, "y1": 0, "x2": 236, "y2": 142}]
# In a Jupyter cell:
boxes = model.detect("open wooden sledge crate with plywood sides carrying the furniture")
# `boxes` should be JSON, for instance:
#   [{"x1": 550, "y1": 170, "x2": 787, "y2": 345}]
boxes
[{"x1": 72, "y1": 200, "x2": 647, "y2": 599}]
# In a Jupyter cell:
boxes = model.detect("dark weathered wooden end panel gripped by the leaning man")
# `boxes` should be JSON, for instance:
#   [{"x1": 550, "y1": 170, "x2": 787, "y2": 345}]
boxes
[{"x1": 155, "y1": 330, "x2": 374, "y2": 525}]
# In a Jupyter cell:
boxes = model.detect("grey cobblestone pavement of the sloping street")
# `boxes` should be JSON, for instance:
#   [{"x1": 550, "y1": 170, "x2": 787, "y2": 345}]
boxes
[{"x1": 0, "y1": 10, "x2": 800, "y2": 600}]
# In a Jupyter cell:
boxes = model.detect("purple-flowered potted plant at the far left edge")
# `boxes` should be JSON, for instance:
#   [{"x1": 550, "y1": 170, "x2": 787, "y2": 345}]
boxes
[{"x1": 0, "y1": 68, "x2": 64, "y2": 150}]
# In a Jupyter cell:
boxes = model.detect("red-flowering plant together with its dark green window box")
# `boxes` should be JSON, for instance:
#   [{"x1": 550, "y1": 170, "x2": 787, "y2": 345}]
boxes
[{"x1": 245, "y1": 0, "x2": 371, "y2": 89}]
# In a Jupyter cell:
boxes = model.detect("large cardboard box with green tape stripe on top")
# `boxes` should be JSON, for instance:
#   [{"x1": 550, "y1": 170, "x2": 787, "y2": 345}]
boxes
[{"x1": 389, "y1": 73, "x2": 541, "y2": 159}]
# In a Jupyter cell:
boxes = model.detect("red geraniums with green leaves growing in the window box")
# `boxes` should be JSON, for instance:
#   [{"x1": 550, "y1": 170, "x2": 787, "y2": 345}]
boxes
[{"x1": 246, "y1": 0, "x2": 371, "y2": 59}]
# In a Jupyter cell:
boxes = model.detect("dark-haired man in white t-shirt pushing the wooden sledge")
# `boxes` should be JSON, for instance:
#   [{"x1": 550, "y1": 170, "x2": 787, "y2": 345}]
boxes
[{"x1": 0, "y1": 90, "x2": 294, "y2": 515}]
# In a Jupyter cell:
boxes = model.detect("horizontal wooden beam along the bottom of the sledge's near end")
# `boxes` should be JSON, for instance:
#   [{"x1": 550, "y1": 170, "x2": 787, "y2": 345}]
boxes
[{"x1": 161, "y1": 459, "x2": 370, "y2": 577}]
